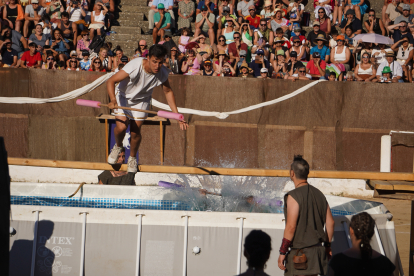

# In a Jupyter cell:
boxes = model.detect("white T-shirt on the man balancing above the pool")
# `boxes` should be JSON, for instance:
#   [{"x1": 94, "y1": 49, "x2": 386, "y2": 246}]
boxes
[{"x1": 118, "y1": 58, "x2": 170, "y2": 102}]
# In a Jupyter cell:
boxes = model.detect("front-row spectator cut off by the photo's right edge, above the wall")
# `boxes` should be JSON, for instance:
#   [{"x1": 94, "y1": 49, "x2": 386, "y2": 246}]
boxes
[{"x1": 391, "y1": 35, "x2": 414, "y2": 83}]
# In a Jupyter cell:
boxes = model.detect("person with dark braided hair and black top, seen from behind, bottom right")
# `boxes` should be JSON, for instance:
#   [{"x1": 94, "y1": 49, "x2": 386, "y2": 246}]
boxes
[{"x1": 327, "y1": 212, "x2": 395, "y2": 276}]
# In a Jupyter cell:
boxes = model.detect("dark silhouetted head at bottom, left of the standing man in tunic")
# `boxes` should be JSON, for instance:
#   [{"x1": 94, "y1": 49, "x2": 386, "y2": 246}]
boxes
[{"x1": 239, "y1": 230, "x2": 272, "y2": 276}]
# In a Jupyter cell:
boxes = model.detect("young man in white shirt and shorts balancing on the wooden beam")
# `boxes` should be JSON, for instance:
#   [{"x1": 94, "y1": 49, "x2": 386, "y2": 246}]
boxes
[{"x1": 106, "y1": 44, "x2": 188, "y2": 173}]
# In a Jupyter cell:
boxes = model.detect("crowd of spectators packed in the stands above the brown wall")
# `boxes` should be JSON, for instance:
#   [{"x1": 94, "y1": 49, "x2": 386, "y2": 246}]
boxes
[{"x1": 0, "y1": 0, "x2": 414, "y2": 82}]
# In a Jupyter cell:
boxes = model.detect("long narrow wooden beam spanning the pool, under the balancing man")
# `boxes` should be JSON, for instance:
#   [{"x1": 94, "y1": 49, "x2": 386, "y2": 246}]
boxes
[{"x1": 8, "y1": 157, "x2": 414, "y2": 181}]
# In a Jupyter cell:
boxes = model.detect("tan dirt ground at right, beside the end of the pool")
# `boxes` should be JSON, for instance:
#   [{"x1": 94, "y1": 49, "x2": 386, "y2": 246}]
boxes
[{"x1": 352, "y1": 198, "x2": 411, "y2": 275}]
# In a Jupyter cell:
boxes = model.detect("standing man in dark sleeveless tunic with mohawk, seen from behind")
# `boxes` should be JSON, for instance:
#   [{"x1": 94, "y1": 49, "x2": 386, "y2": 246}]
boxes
[{"x1": 278, "y1": 155, "x2": 335, "y2": 276}]
